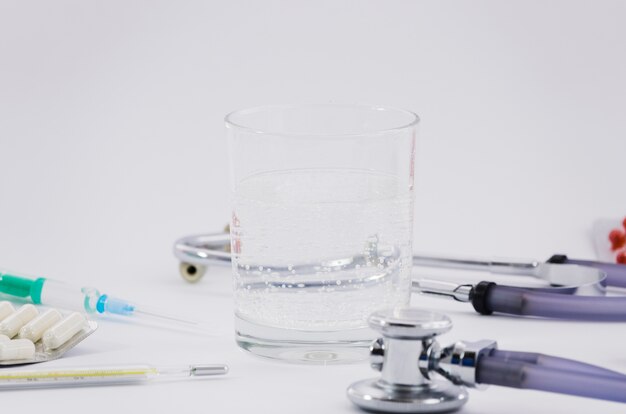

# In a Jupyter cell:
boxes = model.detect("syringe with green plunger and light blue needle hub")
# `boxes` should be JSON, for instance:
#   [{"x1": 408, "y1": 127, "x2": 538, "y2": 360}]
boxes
[{"x1": 0, "y1": 270, "x2": 199, "y2": 327}]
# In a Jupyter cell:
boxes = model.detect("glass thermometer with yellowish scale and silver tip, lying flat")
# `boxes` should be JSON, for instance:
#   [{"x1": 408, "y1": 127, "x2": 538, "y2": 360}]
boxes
[{"x1": 0, "y1": 364, "x2": 228, "y2": 390}]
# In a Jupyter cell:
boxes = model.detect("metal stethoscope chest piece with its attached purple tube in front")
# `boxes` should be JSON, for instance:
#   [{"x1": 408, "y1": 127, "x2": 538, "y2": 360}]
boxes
[{"x1": 347, "y1": 308, "x2": 626, "y2": 413}]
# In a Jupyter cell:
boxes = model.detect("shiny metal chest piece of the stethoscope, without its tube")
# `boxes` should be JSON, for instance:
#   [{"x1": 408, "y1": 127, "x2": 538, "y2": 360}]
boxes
[{"x1": 347, "y1": 308, "x2": 468, "y2": 413}]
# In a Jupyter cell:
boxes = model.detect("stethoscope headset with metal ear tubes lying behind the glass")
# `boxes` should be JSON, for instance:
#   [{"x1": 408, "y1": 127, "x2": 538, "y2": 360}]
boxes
[{"x1": 174, "y1": 233, "x2": 626, "y2": 321}]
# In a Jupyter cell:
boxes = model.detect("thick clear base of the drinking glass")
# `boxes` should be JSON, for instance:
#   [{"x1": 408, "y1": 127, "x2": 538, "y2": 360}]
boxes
[{"x1": 235, "y1": 315, "x2": 376, "y2": 365}]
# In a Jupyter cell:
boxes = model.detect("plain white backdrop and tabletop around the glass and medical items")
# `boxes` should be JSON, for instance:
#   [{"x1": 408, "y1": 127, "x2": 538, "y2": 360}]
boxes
[{"x1": 0, "y1": 0, "x2": 626, "y2": 413}]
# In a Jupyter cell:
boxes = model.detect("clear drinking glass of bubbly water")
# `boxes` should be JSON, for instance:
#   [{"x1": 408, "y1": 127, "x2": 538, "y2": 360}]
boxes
[{"x1": 226, "y1": 104, "x2": 419, "y2": 364}]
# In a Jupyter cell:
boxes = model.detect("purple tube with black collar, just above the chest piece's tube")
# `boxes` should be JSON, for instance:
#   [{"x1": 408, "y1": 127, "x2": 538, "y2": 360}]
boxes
[{"x1": 470, "y1": 282, "x2": 626, "y2": 322}]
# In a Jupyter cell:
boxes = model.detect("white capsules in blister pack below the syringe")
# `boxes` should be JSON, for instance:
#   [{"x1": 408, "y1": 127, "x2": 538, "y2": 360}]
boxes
[{"x1": 0, "y1": 302, "x2": 89, "y2": 362}]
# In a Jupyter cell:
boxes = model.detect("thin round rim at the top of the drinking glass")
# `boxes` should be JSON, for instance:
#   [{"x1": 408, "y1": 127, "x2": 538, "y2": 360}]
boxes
[{"x1": 224, "y1": 103, "x2": 420, "y2": 138}]
